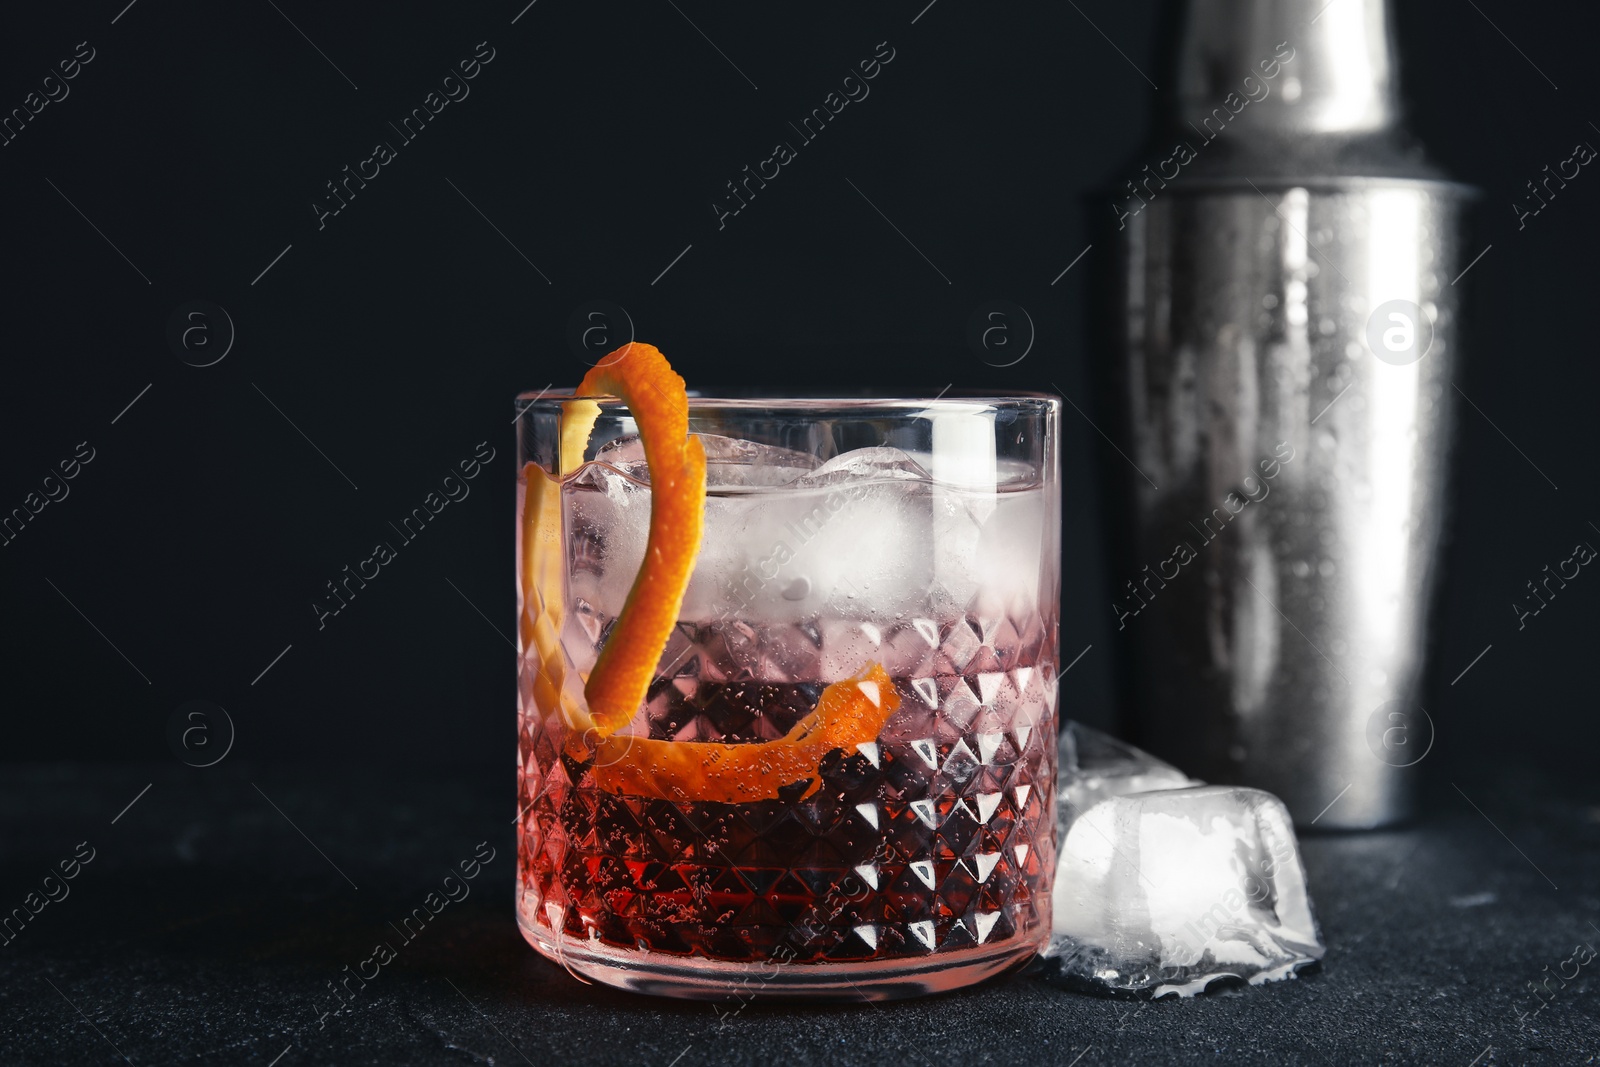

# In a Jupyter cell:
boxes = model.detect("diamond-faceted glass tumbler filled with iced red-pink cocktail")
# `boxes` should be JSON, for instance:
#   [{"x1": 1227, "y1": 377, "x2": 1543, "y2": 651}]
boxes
[{"x1": 517, "y1": 394, "x2": 1061, "y2": 1003}]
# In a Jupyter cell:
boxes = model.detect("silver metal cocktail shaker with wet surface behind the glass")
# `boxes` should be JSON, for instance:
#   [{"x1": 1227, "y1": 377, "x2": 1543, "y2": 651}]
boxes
[{"x1": 1093, "y1": 0, "x2": 1470, "y2": 827}]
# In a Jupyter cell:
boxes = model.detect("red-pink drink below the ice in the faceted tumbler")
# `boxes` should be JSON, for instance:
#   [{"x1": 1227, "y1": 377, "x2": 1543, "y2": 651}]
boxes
[{"x1": 518, "y1": 614, "x2": 1056, "y2": 965}]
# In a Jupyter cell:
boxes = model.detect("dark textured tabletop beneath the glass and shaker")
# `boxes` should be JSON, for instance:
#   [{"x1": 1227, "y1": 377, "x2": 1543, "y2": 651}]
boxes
[{"x1": 0, "y1": 763, "x2": 1600, "y2": 1067}]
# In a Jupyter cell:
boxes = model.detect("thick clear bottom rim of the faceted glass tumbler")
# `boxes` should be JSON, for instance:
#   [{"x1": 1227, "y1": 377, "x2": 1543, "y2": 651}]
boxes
[{"x1": 517, "y1": 917, "x2": 1038, "y2": 1008}]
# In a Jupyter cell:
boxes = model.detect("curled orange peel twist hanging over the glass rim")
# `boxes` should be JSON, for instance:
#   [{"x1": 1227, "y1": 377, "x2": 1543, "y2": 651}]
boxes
[{"x1": 522, "y1": 341, "x2": 899, "y2": 803}]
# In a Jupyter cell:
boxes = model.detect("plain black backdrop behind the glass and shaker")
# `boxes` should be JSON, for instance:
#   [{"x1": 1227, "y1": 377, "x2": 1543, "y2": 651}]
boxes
[{"x1": 0, "y1": 0, "x2": 1600, "y2": 792}]
